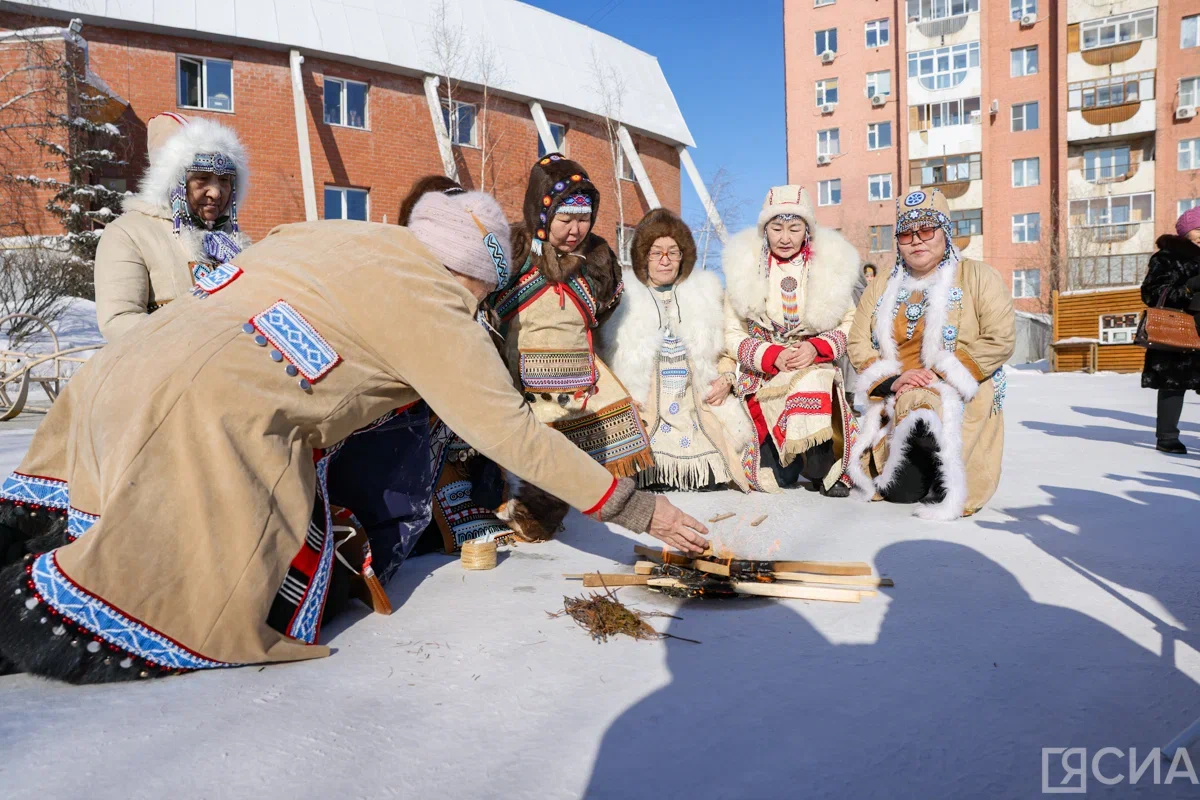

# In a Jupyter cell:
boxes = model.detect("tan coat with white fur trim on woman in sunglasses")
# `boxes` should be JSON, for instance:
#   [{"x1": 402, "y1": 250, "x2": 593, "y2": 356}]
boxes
[{"x1": 850, "y1": 259, "x2": 1015, "y2": 521}]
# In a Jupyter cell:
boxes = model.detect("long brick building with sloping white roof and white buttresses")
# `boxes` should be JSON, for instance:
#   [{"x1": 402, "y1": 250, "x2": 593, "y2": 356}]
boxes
[{"x1": 0, "y1": 0, "x2": 715, "y2": 263}]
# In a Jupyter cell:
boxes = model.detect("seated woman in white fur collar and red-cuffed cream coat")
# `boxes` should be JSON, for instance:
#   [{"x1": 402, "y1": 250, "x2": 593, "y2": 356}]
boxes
[{"x1": 722, "y1": 186, "x2": 859, "y2": 498}]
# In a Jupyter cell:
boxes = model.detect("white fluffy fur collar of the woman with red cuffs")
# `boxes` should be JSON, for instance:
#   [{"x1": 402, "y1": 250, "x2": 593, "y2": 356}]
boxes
[{"x1": 721, "y1": 225, "x2": 860, "y2": 331}]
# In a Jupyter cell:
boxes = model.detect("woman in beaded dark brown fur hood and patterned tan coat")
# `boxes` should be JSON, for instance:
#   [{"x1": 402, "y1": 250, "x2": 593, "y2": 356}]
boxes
[{"x1": 491, "y1": 152, "x2": 654, "y2": 541}]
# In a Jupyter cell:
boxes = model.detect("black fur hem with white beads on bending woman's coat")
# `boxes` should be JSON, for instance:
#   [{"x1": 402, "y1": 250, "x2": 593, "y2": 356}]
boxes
[{"x1": 0, "y1": 557, "x2": 178, "y2": 684}]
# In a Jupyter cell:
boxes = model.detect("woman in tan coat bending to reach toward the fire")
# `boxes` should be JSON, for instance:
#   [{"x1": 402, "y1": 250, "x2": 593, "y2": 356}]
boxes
[{"x1": 0, "y1": 192, "x2": 707, "y2": 682}]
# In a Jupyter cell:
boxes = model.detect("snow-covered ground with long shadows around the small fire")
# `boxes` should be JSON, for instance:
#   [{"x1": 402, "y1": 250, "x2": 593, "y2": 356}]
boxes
[{"x1": 0, "y1": 368, "x2": 1200, "y2": 800}]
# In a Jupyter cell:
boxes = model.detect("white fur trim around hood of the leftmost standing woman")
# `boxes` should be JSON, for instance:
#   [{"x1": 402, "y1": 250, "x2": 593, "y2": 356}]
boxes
[{"x1": 125, "y1": 118, "x2": 250, "y2": 217}]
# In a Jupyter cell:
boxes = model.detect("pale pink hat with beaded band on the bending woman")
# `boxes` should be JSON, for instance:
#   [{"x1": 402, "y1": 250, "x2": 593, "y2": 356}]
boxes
[{"x1": 408, "y1": 192, "x2": 511, "y2": 287}]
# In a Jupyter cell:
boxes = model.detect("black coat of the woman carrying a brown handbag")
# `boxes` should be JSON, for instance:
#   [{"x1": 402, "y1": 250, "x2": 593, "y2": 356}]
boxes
[{"x1": 1141, "y1": 235, "x2": 1200, "y2": 391}]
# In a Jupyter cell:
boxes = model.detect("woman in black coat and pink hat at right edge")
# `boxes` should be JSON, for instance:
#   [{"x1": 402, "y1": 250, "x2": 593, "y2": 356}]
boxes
[{"x1": 1141, "y1": 206, "x2": 1200, "y2": 456}]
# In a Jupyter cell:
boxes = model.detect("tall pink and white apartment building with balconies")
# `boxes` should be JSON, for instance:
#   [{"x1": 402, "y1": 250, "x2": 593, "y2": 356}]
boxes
[{"x1": 784, "y1": 0, "x2": 1200, "y2": 312}]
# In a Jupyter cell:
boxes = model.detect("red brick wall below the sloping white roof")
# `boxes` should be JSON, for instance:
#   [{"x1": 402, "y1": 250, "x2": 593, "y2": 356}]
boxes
[{"x1": 0, "y1": 13, "x2": 680, "y2": 251}]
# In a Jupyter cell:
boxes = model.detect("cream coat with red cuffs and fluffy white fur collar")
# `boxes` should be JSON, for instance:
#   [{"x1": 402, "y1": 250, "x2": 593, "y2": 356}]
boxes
[{"x1": 722, "y1": 221, "x2": 859, "y2": 491}]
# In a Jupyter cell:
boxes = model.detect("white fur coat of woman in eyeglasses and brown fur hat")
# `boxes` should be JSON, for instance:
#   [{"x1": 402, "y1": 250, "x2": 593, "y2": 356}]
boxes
[{"x1": 600, "y1": 270, "x2": 754, "y2": 489}]
